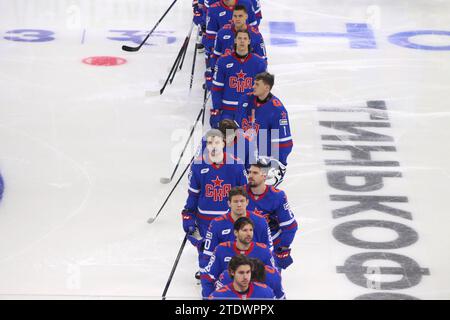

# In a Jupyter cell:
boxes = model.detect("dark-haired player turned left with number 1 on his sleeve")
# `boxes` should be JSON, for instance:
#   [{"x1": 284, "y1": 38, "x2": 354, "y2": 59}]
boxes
[{"x1": 236, "y1": 72, "x2": 294, "y2": 166}]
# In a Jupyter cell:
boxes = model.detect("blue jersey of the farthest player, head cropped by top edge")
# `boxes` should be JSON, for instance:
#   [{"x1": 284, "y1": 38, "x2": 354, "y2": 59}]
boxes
[{"x1": 203, "y1": 0, "x2": 257, "y2": 54}]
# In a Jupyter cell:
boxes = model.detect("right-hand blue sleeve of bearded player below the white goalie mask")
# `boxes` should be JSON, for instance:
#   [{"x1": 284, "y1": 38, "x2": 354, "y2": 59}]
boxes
[{"x1": 275, "y1": 191, "x2": 298, "y2": 247}]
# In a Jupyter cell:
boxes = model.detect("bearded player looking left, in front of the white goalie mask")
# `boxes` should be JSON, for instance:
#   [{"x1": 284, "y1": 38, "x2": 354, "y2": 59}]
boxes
[{"x1": 246, "y1": 158, "x2": 298, "y2": 269}]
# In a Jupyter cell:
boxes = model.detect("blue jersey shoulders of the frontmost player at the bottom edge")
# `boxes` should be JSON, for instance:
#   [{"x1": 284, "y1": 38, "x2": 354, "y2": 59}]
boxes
[{"x1": 208, "y1": 282, "x2": 275, "y2": 300}]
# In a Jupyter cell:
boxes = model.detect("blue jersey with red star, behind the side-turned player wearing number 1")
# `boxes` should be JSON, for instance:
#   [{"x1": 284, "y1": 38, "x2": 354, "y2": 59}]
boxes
[{"x1": 211, "y1": 52, "x2": 267, "y2": 115}]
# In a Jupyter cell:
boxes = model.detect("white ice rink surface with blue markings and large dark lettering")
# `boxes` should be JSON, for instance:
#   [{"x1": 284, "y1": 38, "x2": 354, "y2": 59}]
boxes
[{"x1": 0, "y1": 0, "x2": 450, "y2": 299}]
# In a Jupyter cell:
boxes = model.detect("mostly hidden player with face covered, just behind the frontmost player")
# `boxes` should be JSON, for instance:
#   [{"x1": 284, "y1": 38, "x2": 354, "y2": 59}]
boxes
[{"x1": 216, "y1": 258, "x2": 286, "y2": 300}]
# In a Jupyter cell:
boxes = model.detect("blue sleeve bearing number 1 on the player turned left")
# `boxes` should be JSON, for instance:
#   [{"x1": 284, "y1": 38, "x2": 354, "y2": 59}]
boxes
[{"x1": 271, "y1": 104, "x2": 294, "y2": 165}]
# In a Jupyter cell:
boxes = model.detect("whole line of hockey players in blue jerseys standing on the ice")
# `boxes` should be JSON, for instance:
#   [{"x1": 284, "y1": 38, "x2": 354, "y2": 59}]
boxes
[{"x1": 182, "y1": 0, "x2": 298, "y2": 299}]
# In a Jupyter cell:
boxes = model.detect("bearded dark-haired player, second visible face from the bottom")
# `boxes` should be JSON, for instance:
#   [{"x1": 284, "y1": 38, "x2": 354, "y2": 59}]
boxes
[{"x1": 201, "y1": 217, "x2": 275, "y2": 297}]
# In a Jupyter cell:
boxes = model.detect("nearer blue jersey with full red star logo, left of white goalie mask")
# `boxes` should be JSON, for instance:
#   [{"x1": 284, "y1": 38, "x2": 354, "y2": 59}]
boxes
[{"x1": 185, "y1": 153, "x2": 247, "y2": 222}]
